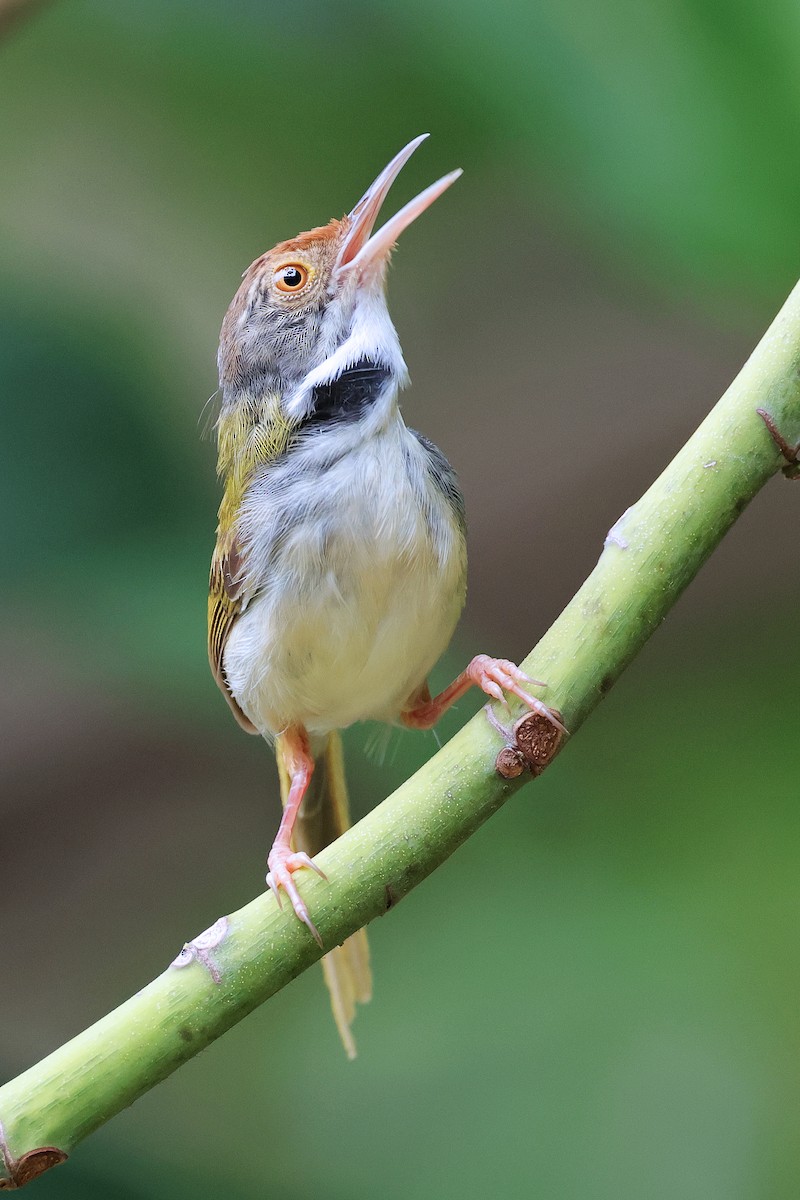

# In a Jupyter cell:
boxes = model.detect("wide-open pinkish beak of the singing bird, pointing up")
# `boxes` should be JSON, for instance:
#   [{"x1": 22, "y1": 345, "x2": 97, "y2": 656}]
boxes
[{"x1": 336, "y1": 133, "x2": 461, "y2": 276}]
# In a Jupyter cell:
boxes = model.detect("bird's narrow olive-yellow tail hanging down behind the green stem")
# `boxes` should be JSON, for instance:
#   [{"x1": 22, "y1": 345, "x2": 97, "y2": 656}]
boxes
[{"x1": 278, "y1": 732, "x2": 372, "y2": 1058}]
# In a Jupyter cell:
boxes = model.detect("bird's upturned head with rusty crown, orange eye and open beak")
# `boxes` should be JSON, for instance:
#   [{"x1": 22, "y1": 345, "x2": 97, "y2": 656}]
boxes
[{"x1": 219, "y1": 134, "x2": 461, "y2": 420}]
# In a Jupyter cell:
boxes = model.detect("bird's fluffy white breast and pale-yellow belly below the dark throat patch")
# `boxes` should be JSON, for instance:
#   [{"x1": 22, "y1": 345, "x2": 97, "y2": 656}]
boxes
[{"x1": 224, "y1": 418, "x2": 465, "y2": 734}]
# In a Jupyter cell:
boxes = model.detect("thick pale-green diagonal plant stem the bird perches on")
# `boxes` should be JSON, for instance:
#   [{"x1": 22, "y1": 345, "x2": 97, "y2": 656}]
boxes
[{"x1": 0, "y1": 286, "x2": 800, "y2": 1187}]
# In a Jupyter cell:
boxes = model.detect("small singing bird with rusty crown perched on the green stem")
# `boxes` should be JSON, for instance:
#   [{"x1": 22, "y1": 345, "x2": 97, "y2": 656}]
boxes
[{"x1": 209, "y1": 134, "x2": 561, "y2": 1057}]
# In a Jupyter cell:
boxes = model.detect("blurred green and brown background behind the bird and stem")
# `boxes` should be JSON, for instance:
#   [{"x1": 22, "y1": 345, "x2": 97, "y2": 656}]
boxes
[{"x1": 0, "y1": 0, "x2": 800, "y2": 1200}]
